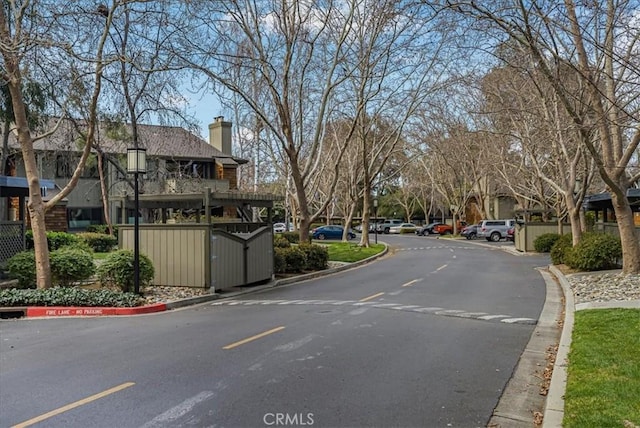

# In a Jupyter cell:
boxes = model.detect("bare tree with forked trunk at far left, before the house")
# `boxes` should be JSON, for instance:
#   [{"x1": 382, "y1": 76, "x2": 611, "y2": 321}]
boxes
[{"x1": 0, "y1": 0, "x2": 118, "y2": 288}]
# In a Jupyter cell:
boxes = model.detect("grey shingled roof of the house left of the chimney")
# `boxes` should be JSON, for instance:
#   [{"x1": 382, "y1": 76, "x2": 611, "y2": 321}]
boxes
[{"x1": 9, "y1": 120, "x2": 247, "y2": 165}]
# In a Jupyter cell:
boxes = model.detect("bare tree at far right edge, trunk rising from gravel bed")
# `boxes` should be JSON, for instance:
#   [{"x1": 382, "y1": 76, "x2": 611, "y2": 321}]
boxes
[{"x1": 448, "y1": 0, "x2": 640, "y2": 273}]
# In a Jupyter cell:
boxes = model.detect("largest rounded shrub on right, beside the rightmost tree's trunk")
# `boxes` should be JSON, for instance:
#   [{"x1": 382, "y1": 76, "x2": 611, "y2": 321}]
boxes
[{"x1": 565, "y1": 232, "x2": 622, "y2": 271}]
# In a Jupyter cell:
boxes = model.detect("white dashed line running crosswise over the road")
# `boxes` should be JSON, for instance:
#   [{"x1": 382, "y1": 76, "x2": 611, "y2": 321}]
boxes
[{"x1": 211, "y1": 300, "x2": 537, "y2": 325}]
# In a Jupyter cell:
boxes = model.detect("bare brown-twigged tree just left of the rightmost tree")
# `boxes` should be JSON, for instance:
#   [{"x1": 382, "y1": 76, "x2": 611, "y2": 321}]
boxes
[{"x1": 483, "y1": 51, "x2": 595, "y2": 241}]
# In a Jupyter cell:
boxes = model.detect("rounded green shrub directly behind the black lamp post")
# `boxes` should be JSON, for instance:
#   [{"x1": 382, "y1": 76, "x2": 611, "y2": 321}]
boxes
[{"x1": 97, "y1": 250, "x2": 155, "y2": 292}]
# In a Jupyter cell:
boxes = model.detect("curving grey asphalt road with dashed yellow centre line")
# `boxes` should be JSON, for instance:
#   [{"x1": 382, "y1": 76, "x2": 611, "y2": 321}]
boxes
[{"x1": 0, "y1": 236, "x2": 548, "y2": 427}]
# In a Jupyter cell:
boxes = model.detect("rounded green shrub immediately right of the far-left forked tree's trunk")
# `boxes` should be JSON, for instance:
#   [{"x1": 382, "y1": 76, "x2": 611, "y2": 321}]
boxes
[{"x1": 49, "y1": 247, "x2": 96, "y2": 287}]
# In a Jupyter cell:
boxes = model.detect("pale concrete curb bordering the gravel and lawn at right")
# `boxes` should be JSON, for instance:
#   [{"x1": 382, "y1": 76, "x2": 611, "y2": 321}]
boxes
[{"x1": 542, "y1": 265, "x2": 575, "y2": 428}]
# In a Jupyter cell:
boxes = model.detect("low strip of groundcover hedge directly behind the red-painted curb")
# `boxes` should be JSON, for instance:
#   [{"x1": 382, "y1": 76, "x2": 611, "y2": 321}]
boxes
[{"x1": 0, "y1": 287, "x2": 142, "y2": 308}]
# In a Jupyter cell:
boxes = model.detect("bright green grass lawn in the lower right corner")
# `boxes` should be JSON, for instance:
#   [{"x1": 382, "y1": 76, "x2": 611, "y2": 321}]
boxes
[{"x1": 563, "y1": 309, "x2": 640, "y2": 428}]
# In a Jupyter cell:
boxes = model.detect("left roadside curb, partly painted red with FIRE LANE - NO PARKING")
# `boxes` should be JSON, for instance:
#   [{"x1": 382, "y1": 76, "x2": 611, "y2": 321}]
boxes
[{"x1": 6, "y1": 242, "x2": 389, "y2": 318}]
